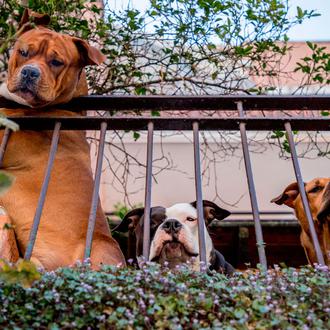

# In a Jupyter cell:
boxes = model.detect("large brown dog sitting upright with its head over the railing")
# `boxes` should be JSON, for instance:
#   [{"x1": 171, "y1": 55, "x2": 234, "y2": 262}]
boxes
[{"x1": 0, "y1": 10, "x2": 125, "y2": 270}]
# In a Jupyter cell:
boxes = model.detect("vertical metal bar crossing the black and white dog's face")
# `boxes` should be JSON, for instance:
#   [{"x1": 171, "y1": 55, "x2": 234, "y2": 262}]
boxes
[{"x1": 193, "y1": 121, "x2": 207, "y2": 271}]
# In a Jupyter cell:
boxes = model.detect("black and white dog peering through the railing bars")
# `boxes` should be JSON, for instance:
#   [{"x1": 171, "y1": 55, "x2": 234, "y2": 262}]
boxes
[{"x1": 114, "y1": 200, "x2": 235, "y2": 275}]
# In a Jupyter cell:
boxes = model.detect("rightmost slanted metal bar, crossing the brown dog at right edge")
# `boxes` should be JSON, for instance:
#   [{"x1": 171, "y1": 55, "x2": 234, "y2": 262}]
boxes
[{"x1": 284, "y1": 122, "x2": 325, "y2": 265}]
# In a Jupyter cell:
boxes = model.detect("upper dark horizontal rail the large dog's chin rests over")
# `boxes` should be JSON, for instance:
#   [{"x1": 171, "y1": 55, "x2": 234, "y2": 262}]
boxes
[{"x1": 0, "y1": 95, "x2": 330, "y2": 111}]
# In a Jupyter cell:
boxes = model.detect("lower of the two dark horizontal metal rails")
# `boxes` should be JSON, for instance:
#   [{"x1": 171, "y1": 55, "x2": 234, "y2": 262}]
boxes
[{"x1": 3, "y1": 116, "x2": 330, "y2": 131}]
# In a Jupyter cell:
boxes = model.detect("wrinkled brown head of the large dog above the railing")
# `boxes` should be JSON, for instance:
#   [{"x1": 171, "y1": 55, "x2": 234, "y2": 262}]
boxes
[{"x1": 7, "y1": 11, "x2": 105, "y2": 107}]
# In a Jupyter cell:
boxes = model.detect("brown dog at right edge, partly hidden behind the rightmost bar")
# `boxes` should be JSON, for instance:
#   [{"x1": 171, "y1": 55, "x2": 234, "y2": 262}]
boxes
[{"x1": 271, "y1": 178, "x2": 330, "y2": 266}]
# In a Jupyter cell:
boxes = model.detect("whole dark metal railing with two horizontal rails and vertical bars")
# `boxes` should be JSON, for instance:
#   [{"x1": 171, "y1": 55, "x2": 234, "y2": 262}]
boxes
[{"x1": 0, "y1": 96, "x2": 330, "y2": 267}]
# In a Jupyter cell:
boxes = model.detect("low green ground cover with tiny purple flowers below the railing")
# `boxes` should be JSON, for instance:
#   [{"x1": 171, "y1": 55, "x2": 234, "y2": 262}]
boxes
[{"x1": 0, "y1": 264, "x2": 330, "y2": 329}]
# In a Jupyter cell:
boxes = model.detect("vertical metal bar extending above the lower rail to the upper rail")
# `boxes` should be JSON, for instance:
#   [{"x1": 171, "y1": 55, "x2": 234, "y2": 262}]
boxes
[{"x1": 237, "y1": 101, "x2": 267, "y2": 268}]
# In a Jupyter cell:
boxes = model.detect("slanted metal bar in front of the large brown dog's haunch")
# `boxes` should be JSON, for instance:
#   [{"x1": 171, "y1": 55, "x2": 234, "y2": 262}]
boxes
[{"x1": 84, "y1": 122, "x2": 107, "y2": 259}]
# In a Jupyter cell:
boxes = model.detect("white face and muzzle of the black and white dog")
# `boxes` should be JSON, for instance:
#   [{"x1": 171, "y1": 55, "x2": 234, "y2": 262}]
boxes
[{"x1": 149, "y1": 203, "x2": 212, "y2": 268}]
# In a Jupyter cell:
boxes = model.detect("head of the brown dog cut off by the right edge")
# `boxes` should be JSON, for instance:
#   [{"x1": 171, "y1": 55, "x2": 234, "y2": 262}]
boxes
[{"x1": 271, "y1": 178, "x2": 330, "y2": 223}]
